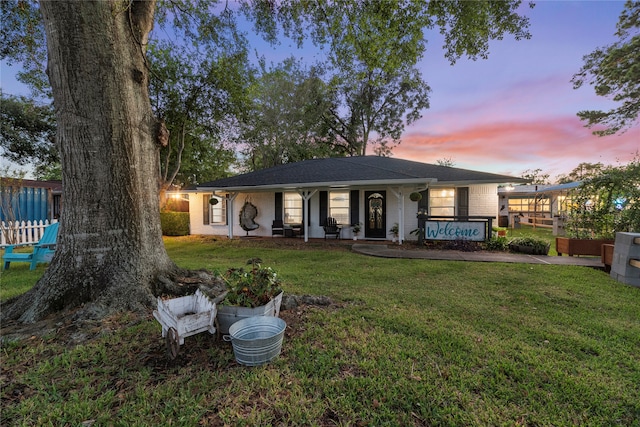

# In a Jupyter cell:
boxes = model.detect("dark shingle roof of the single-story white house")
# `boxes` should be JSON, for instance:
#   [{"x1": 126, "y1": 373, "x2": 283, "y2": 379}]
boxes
[{"x1": 198, "y1": 156, "x2": 522, "y2": 189}]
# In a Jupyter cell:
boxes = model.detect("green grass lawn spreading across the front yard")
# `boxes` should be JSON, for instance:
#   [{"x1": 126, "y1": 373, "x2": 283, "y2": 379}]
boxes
[{"x1": 0, "y1": 238, "x2": 640, "y2": 426}]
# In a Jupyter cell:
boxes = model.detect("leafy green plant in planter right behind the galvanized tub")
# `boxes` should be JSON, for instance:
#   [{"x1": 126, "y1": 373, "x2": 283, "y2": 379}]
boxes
[{"x1": 216, "y1": 258, "x2": 282, "y2": 334}]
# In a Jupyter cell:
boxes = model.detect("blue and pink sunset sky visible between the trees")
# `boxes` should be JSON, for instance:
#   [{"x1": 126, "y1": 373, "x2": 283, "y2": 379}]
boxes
[{"x1": 0, "y1": 0, "x2": 640, "y2": 181}]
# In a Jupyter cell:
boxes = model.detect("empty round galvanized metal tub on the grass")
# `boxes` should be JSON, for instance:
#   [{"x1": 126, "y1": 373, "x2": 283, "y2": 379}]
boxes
[{"x1": 223, "y1": 316, "x2": 287, "y2": 366}]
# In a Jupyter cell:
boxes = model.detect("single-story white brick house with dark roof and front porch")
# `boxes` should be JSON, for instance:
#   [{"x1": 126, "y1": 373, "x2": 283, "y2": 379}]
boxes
[{"x1": 183, "y1": 156, "x2": 524, "y2": 242}]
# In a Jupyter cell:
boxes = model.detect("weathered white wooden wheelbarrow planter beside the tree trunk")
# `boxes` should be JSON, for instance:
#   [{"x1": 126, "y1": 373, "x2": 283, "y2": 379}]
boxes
[{"x1": 153, "y1": 289, "x2": 216, "y2": 345}]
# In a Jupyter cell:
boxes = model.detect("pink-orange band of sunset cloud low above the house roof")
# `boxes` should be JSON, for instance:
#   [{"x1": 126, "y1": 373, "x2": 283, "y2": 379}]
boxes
[{"x1": 394, "y1": 116, "x2": 640, "y2": 179}]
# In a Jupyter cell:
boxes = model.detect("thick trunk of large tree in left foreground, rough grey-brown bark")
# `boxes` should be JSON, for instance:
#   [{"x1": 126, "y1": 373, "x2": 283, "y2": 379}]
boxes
[{"x1": 3, "y1": 0, "x2": 176, "y2": 322}]
